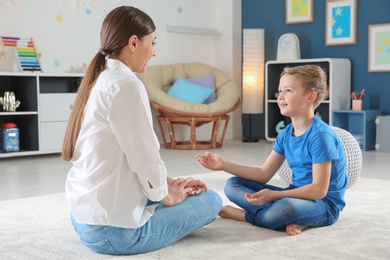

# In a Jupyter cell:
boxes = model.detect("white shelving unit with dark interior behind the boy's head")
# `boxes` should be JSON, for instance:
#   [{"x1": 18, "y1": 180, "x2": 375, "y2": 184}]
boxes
[{"x1": 265, "y1": 58, "x2": 351, "y2": 141}]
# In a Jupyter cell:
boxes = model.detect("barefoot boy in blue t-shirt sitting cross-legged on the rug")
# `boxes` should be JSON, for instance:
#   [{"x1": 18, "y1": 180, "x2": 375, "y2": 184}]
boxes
[{"x1": 197, "y1": 65, "x2": 347, "y2": 235}]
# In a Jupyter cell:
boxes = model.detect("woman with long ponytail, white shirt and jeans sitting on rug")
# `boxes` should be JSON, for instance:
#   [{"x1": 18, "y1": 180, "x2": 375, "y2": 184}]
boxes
[{"x1": 62, "y1": 6, "x2": 222, "y2": 254}]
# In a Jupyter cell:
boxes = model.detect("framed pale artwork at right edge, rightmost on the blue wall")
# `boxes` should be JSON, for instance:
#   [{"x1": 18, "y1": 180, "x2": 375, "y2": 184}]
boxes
[{"x1": 368, "y1": 23, "x2": 390, "y2": 72}]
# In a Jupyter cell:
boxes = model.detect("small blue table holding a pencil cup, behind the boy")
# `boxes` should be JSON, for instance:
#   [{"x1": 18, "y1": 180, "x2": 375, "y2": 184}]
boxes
[{"x1": 332, "y1": 109, "x2": 382, "y2": 151}]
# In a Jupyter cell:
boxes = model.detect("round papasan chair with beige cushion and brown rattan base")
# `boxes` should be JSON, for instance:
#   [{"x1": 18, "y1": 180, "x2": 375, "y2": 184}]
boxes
[{"x1": 138, "y1": 62, "x2": 240, "y2": 150}]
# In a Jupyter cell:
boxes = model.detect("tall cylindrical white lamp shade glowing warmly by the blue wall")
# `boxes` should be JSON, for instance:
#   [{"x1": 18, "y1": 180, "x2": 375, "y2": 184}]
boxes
[{"x1": 242, "y1": 29, "x2": 264, "y2": 114}]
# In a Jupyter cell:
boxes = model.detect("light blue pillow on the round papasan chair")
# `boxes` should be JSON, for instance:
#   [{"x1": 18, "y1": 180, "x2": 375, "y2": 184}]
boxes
[{"x1": 167, "y1": 78, "x2": 214, "y2": 104}]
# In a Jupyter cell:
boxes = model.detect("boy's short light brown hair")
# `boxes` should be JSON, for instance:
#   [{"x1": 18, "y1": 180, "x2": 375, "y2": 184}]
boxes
[{"x1": 280, "y1": 65, "x2": 326, "y2": 108}]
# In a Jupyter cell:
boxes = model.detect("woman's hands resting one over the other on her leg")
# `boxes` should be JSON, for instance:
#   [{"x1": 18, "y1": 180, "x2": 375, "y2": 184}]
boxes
[{"x1": 161, "y1": 178, "x2": 208, "y2": 206}]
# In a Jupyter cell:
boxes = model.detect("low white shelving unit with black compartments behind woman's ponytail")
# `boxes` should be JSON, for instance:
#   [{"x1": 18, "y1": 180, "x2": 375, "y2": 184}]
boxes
[{"x1": 0, "y1": 73, "x2": 83, "y2": 158}]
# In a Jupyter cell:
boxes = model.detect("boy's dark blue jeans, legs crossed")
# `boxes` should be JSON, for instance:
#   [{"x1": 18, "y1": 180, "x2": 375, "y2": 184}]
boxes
[{"x1": 225, "y1": 177, "x2": 340, "y2": 230}]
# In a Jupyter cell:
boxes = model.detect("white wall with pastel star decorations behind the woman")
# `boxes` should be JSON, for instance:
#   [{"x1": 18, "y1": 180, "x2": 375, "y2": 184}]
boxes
[{"x1": 0, "y1": 0, "x2": 241, "y2": 142}]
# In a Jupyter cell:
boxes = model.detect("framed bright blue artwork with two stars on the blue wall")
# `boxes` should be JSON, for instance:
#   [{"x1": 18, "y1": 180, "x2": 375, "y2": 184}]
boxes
[{"x1": 325, "y1": 0, "x2": 357, "y2": 46}]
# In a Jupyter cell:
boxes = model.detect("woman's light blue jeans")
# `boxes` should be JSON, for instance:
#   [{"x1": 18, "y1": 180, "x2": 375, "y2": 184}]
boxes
[{"x1": 71, "y1": 190, "x2": 222, "y2": 255}]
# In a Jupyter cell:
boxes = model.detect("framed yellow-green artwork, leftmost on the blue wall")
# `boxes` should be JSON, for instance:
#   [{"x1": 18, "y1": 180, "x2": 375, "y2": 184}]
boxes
[{"x1": 286, "y1": 0, "x2": 314, "y2": 24}]
